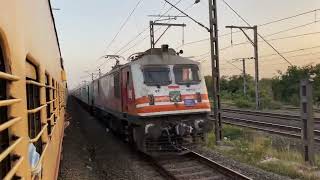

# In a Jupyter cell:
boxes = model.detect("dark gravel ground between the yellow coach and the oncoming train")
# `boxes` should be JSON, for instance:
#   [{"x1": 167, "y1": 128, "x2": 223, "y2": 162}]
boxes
[{"x1": 58, "y1": 98, "x2": 166, "y2": 180}]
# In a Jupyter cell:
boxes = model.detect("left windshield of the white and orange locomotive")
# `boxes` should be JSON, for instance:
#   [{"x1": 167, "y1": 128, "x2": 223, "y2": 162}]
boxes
[{"x1": 143, "y1": 66, "x2": 171, "y2": 86}]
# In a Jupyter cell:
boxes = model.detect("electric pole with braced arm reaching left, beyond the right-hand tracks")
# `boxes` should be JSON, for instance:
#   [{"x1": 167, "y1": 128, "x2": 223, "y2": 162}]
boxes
[{"x1": 226, "y1": 26, "x2": 260, "y2": 110}]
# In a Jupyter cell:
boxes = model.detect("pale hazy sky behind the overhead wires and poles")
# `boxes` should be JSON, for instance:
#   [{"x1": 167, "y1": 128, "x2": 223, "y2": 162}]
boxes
[{"x1": 51, "y1": 0, "x2": 320, "y2": 88}]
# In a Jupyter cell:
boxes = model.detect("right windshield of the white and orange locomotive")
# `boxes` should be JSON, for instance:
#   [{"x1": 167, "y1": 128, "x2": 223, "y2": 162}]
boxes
[{"x1": 173, "y1": 65, "x2": 200, "y2": 84}]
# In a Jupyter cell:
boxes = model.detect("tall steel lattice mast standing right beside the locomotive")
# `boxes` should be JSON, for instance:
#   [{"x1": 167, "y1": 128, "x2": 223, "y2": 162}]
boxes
[{"x1": 209, "y1": 0, "x2": 222, "y2": 144}]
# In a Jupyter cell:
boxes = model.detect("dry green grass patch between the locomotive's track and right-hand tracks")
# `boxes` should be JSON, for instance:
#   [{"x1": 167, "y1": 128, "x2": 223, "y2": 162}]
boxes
[{"x1": 206, "y1": 125, "x2": 320, "y2": 180}]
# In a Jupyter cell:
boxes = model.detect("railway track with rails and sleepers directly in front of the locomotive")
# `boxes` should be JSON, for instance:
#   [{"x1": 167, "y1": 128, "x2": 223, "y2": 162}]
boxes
[{"x1": 143, "y1": 151, "x2": 251, "y2": 180}]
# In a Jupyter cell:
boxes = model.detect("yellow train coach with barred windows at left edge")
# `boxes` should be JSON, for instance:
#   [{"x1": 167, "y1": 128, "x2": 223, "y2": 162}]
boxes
[{"x1": 0, "y1": 0, "x2": 67, "y2": 180}]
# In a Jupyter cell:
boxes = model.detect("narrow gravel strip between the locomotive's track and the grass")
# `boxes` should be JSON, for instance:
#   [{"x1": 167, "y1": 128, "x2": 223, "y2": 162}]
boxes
[{"x1": 194, "y1": 147, "x2": 290, "y2": 180}]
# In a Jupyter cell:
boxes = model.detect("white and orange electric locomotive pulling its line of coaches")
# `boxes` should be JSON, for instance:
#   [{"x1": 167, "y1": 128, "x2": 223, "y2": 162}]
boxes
[{"x1": 73, "y1": 45, "x2": 212, "y2": 153}]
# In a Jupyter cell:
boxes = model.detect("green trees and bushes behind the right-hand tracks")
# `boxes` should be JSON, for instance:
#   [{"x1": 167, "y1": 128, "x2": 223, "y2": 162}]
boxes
[{"x1": 205, "y1": 64, "x2": 320, "y2": 109}]
